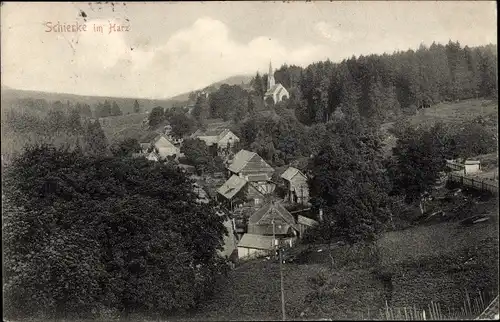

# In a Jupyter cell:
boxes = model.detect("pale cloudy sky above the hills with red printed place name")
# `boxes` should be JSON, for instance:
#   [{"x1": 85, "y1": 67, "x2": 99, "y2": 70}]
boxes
[{"x1": 0, "y1": 1, "x2": 497, "y2": 98}]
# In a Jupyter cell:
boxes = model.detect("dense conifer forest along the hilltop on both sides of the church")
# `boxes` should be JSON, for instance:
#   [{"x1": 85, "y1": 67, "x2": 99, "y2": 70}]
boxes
[{"x1": 188, "y1": 41, "x2": 498, "y2": 125}]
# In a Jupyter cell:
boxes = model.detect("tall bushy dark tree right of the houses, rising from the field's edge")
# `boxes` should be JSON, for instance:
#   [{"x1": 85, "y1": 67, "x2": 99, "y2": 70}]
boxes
[{"x1": 307, "y1": 118, "x2": 390, "y2": 242}]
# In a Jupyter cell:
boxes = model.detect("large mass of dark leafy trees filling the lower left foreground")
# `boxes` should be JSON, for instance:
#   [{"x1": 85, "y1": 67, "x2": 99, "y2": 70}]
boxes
[{"x1": 3, "y1": 146, "x2": 229, "y2": 318}]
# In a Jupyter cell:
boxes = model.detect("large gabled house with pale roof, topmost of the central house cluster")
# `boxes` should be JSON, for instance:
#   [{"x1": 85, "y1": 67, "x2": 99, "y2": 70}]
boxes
[{"x1": 227, "y1": 150, "x2": 276, "y2": 194}]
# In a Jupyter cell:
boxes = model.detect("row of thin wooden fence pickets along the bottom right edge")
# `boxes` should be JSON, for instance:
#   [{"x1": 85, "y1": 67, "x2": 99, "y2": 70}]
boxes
[{"x1": 361, "y1": 291, "x2": 498, "y2": 321}]
